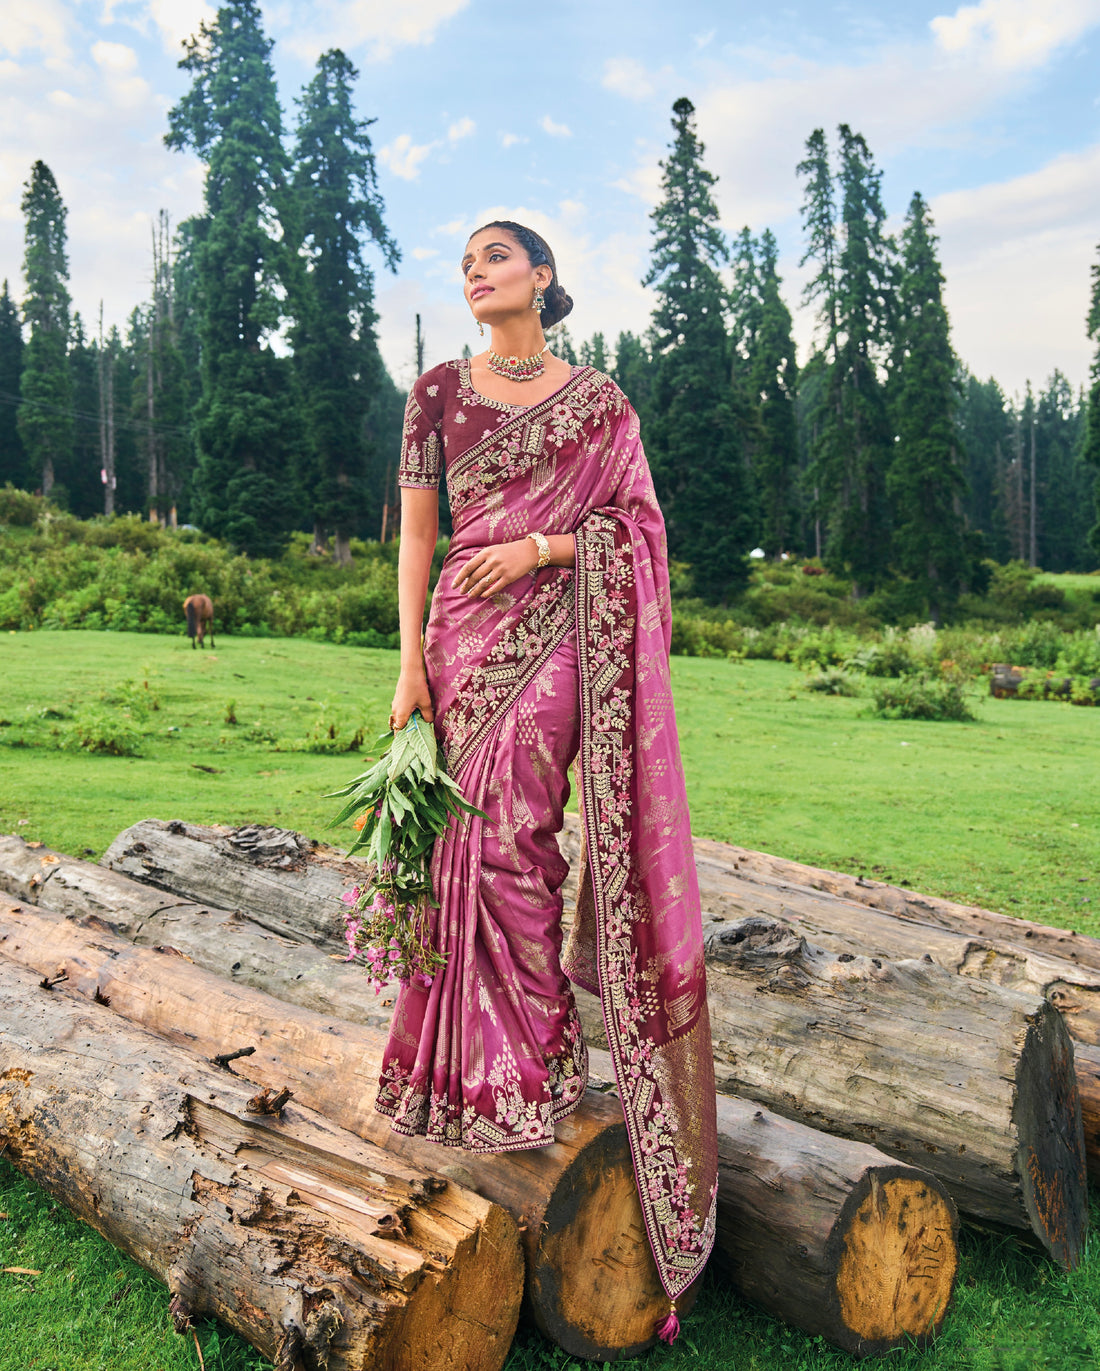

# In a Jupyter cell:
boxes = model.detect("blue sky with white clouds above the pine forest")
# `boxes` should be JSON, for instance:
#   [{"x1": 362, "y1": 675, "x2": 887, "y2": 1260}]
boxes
[{"x1": 0, "y1": 0, "x2": 1100, "y2": 395}]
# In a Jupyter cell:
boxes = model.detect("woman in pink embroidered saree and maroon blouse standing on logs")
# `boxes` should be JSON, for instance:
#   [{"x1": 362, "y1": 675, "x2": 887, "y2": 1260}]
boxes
[{"x1": 377, "y1": 222, "x2": 716, "y2": 1321}]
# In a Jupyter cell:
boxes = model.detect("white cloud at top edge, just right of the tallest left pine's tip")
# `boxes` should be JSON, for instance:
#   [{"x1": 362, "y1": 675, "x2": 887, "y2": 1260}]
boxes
[{"x1": 278, "y1": 0, "x2": 469, "y2": 60}]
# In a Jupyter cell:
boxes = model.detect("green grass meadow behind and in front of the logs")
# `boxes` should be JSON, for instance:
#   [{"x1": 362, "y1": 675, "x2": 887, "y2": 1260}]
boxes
[{"x1": 0, "y1": 632, "x2": 1100, "y2": 1371}]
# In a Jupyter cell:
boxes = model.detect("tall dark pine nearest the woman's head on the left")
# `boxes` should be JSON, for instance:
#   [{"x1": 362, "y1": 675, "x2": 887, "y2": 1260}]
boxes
[{"x1": 292, "y1": 49, "x2": 400, "y2": 562}]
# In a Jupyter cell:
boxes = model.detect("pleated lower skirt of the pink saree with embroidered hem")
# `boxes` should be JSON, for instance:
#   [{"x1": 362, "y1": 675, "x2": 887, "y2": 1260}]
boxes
[{"x1": 377, "y1": 639, "x2": 587, "y2": 1152}]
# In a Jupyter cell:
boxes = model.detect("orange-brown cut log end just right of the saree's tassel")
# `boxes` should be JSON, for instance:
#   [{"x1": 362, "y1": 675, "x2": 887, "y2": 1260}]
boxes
[{"x1": 833, "y1": 1171, "x2": 957, "y2": 1356}]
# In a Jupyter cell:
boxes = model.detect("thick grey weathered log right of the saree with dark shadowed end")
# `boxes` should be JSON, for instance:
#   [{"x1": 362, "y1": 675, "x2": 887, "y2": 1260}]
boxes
[{"x1": 579, "y1": 919, "x2": 1088, "y2": 1270}]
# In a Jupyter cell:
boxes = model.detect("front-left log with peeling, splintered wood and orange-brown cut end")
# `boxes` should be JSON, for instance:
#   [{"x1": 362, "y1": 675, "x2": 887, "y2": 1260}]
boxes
[{"x1": 0, "y1": 960, "x2": 523, "y2": 1371}]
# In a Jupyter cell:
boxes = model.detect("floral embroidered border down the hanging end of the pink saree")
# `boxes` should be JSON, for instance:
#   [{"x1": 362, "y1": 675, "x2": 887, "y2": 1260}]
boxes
[{"x1": 566, "y1": 513, "x2": 716, "y2": 1300}]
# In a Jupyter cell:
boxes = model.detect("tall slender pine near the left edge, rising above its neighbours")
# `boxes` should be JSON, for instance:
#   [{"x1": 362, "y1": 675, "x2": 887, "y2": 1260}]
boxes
[{"x1": 19, "y1": 162, "x2": 73, "y2": 495}]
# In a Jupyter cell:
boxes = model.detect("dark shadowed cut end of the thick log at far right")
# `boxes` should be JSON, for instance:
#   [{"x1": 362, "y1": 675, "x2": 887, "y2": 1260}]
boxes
[{"x1": 1012, "y1": 1006, "x2": 1089, "y2": 1271}]
